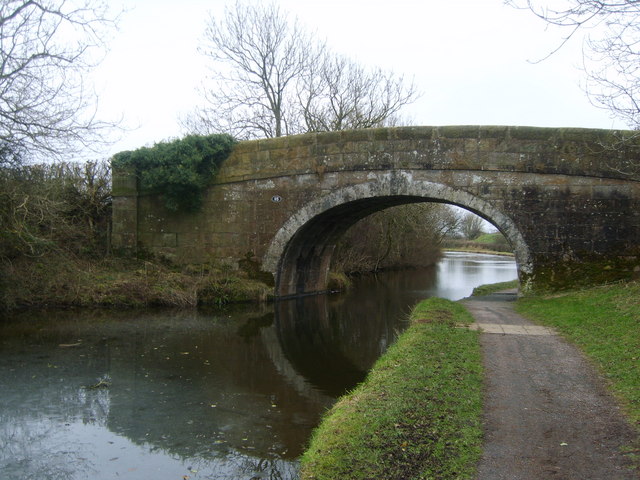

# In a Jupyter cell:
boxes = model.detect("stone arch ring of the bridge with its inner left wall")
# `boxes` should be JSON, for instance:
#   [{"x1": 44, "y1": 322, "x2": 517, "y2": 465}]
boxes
[{"x1": 263, "y1": 171, "x2": 531, "y2": 296}]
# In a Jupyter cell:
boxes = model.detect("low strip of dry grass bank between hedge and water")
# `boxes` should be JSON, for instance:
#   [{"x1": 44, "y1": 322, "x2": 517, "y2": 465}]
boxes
[{"x1": 0, "y1": 252, "x2": 273, "y2": 312}]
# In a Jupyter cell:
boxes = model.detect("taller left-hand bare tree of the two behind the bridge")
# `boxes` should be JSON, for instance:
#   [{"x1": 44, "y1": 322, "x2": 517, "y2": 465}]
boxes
[{"x1": 183, "y1": 2, "x2": 317, "y2": 138}]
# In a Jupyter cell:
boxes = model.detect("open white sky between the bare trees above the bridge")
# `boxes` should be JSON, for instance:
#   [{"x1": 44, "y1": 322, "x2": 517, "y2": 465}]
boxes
[{"x1": 95, "y1": 0, "x2": 625, "y2": 155}]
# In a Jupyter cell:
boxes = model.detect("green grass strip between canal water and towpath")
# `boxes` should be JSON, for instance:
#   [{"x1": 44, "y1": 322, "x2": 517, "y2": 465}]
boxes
[{"x1": 301, "y1": 298, "x2": 482, "y2": 480}]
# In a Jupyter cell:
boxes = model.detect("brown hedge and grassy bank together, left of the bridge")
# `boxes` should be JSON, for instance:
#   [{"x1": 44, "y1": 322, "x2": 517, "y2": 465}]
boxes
[{"x1": 0, "y1": 156, "x2": 272, "y2": 311}]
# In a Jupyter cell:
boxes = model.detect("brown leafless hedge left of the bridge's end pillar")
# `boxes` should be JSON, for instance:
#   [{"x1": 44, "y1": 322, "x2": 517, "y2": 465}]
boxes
[{"x1": 0, "y1": 161, "x2": 111, "y2": 259}]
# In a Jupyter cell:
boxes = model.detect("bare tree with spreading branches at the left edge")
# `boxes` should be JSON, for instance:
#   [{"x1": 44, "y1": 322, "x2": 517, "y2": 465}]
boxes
[{"x1": 0, "y1": 0, "x2": 115, "y2": 165}]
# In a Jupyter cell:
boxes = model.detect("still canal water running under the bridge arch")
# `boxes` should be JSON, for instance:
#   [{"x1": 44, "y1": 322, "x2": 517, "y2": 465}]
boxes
[{"x1": 0, "y1": 252, "x2": 516, "y2": 480}]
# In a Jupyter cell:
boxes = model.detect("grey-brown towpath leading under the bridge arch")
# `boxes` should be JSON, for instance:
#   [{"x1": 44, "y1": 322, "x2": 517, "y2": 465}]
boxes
[{"x1": 464, "y1": 294, "x2": 640, "y2": 480}]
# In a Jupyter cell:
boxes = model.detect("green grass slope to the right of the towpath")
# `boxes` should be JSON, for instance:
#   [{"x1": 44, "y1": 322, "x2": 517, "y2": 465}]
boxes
[{"x1": 516, "y1": 282, "x2": 640, "y2": 429}]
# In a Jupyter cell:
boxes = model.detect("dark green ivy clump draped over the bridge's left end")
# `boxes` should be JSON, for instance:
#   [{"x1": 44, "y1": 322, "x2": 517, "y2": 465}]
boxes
[{"x1": 112, "y1": 134, "x2": 236, "y2": 212}]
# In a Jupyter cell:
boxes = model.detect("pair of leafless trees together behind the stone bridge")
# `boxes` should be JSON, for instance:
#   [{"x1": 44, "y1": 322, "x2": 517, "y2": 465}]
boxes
[{"x1": 182, "y1": 1, "x2": 418, "y2": 139}]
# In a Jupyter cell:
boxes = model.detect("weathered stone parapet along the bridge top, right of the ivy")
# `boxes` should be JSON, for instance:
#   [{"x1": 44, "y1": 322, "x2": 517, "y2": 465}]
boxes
[{"x1": 215, "y1": 126, "x2": 640, "y2": 183}]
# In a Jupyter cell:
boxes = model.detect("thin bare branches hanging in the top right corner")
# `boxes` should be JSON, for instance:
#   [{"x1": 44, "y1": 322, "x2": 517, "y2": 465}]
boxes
[{"x1": 507, "y1": 0, "x2": 640, "y2": 129}]
